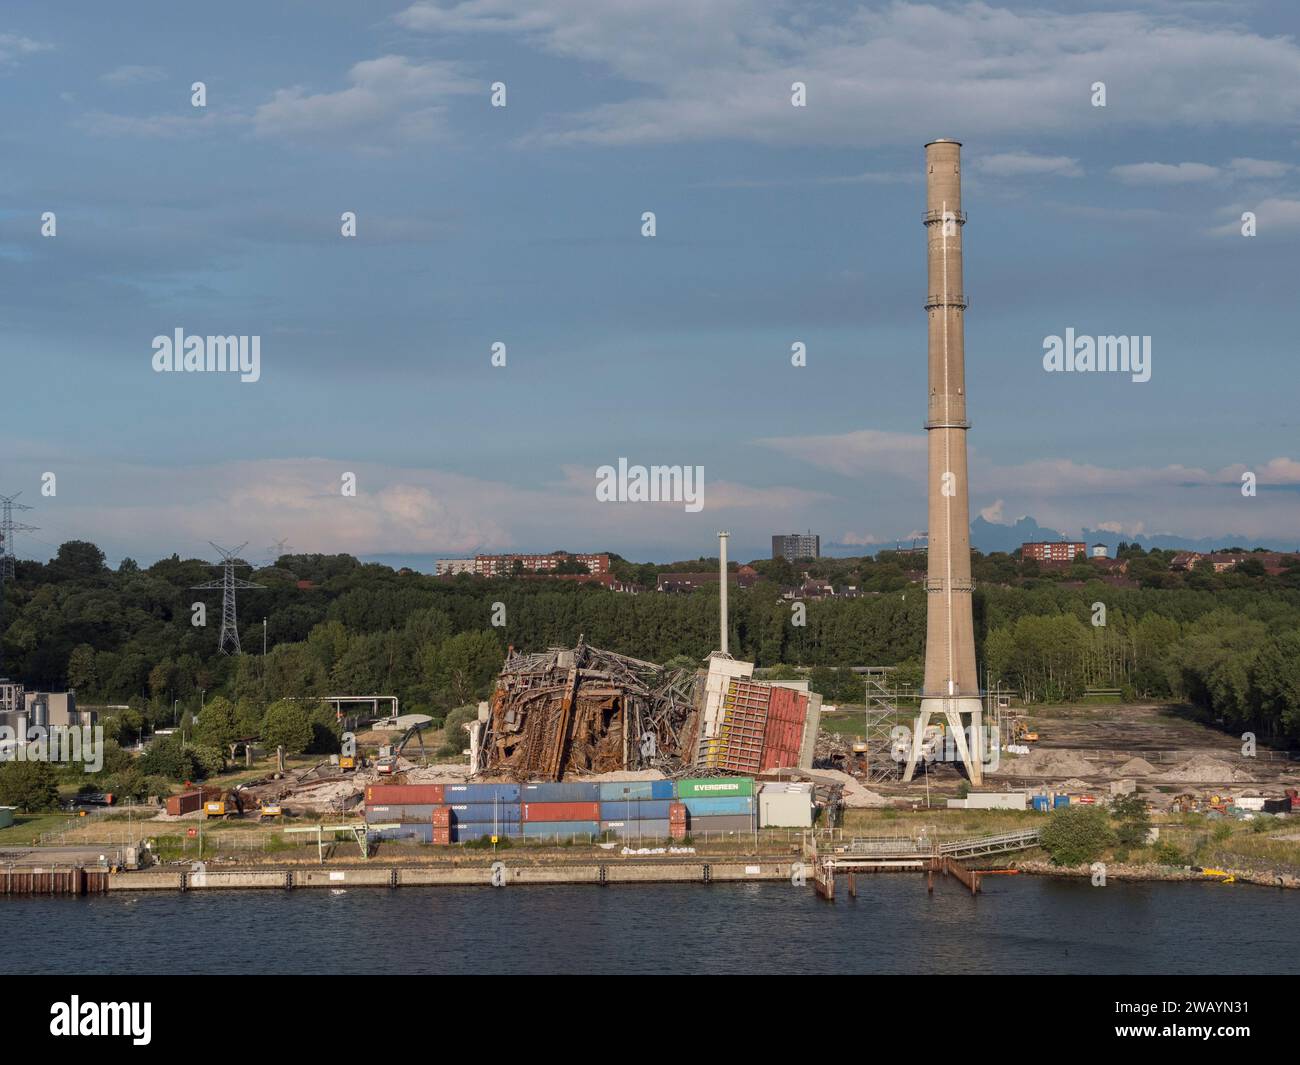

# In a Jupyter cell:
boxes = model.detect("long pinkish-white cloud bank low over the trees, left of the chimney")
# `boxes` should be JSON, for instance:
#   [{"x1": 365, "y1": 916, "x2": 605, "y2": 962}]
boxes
[{"x1": 32, "y1": 458, "x2": 831, "y2": 558}]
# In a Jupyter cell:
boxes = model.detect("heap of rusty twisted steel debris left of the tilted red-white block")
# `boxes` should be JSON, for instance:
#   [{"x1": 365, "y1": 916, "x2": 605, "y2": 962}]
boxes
[{"x1": 475, "y1": 640, "x2": 697, "y2": 780}]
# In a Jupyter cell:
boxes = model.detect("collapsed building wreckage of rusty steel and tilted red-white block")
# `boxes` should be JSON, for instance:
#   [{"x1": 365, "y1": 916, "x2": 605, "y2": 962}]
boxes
[{"x1": 471, "y1": 641, "x2": 822, "y2": 780}]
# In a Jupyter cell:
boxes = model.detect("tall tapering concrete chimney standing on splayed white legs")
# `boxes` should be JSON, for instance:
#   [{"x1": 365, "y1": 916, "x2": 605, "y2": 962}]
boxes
[{"x1": 904, "y1": 140, "x2": 983, "y2": 784}]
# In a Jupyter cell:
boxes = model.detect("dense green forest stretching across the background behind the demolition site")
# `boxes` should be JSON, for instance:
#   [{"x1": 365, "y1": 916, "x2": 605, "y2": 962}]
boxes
[{"x1": 0, "y1": 542, "x2": 1300, "y2": 737}]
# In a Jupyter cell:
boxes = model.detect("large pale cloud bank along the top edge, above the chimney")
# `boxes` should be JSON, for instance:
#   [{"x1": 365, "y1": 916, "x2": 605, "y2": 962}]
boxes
[{"x1": 397, "y1": 0, "x2": 1300, "y2": 147}]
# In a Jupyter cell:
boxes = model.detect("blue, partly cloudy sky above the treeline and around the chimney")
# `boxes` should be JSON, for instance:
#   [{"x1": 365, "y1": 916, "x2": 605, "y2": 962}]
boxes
[{"x1": 0, "y1": 0, "x2": 1300, "y2": 560}]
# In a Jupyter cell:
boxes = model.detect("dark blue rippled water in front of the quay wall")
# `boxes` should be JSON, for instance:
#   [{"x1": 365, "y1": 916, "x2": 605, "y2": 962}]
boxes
[{"x1": 0, "y1": 875, "x2": 1300, "y2": 974}]
